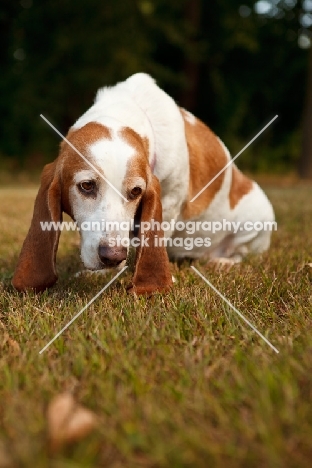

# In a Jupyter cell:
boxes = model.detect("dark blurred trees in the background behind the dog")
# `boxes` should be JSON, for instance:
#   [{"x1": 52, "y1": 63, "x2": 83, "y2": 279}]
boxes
[{"x1": 0, "y1": 0, "x2": 312, "y2": 177}]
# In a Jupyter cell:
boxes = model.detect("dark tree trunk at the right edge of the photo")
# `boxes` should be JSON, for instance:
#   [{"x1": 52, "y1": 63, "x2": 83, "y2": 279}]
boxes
[{"x1": 298, "y1": 47, "x2": 312, "y2": 179}]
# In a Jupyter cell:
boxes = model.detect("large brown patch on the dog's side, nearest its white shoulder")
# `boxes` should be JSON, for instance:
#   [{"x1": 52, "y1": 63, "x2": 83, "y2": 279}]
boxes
[{"x1": 181, "y1": 109, "x2": 228, "y2": 219}]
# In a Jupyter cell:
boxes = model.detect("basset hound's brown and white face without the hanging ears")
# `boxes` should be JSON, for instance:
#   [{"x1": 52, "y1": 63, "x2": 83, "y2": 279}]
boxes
[{"x1": 60, "y1": 123, "x2": 151, "y2": 270}]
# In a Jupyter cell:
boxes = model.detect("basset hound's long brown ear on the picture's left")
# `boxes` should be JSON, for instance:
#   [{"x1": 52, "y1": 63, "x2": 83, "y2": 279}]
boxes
[{"x1": 12, "y1": 162, "x2": 62, "y2": 292}]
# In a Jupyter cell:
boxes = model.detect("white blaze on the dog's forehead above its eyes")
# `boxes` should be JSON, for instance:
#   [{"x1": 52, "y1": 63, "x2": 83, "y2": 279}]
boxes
[{"x1": 89, "y1": 136, "x2": 135, "y2": 192}]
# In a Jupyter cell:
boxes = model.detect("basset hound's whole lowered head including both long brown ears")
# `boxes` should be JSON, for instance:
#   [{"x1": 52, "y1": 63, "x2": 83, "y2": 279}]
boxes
[{"x1": 12, "y1": 122, "x2": 171, "y2": 294}]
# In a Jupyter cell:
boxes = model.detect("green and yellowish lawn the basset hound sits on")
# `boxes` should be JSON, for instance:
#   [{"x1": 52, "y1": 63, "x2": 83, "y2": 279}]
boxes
[{"x1": 0, "y1": 186, "x2": 312, "y2": 468}]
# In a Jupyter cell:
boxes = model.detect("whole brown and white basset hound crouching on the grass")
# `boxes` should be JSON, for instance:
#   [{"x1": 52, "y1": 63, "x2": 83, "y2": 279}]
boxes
[{"x1": 12, "y1": 73, "x2": 274, "y2": 294}]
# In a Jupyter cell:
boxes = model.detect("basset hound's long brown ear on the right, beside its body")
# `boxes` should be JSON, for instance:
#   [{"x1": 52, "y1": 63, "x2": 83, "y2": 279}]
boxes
[{"x1": 128, "y1": 175, "x2": 172, "y2": 294}]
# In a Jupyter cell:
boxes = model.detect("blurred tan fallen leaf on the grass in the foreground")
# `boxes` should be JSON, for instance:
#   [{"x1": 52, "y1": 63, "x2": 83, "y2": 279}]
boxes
[{"x1": 47, "y1": 392, "x2": 97, "y2": 451}]
